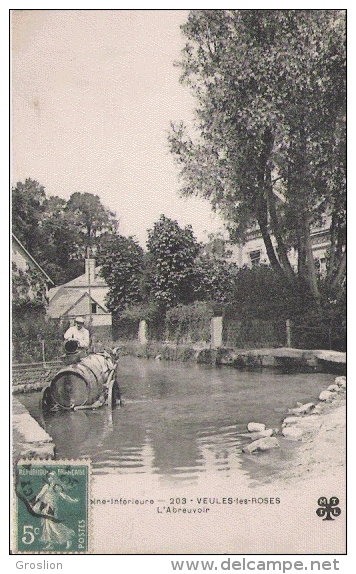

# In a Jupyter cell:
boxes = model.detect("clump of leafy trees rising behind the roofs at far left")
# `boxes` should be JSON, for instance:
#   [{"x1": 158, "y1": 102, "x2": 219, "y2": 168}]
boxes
[{"x1": 12, "y1": 179, "x2": 118, "y2": 284}]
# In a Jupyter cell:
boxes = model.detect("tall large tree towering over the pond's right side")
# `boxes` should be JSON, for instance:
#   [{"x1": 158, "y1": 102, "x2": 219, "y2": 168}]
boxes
[{"x1": 169, "y1": 10, "x2": 346, "y2": 302}]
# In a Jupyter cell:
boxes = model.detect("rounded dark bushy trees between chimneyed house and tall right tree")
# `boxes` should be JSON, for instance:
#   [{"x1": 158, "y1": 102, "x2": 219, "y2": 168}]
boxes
[{"x1": 98, "y1": 215, "x2": 236, "y2": 318}]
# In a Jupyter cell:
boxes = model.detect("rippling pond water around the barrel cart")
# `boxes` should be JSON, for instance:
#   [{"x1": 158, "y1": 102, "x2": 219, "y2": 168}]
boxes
[{"x1": 19, "y1": 357, "x2": 334, "y2": 482}]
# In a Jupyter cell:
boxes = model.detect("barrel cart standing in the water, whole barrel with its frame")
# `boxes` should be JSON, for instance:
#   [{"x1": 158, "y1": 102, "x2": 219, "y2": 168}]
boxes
[{"x1": 41, "y1": 342, "x2": 121, "y2": 411}]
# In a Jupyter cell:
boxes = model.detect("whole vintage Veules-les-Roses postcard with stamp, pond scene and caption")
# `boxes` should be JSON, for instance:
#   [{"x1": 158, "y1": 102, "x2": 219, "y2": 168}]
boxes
[{"x1": 10, "y1": 9, "x2": 347, "y2": 571}]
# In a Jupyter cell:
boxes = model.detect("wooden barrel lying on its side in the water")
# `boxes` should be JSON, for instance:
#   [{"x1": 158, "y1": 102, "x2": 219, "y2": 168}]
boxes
[{"x1": 50, "y1": 354, "x2": 112, "y2": 408}]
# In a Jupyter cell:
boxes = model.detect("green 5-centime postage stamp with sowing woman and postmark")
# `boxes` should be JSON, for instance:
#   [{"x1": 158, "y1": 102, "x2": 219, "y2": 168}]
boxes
[{"x1": 15, "y1": 460, "x2": 90, "y2": 554}]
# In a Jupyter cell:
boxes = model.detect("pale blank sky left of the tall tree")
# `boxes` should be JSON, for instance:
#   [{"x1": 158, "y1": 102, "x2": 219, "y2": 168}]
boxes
[{"x1": 11, "y1": 10, "x2": 222, "y2": 247}]
